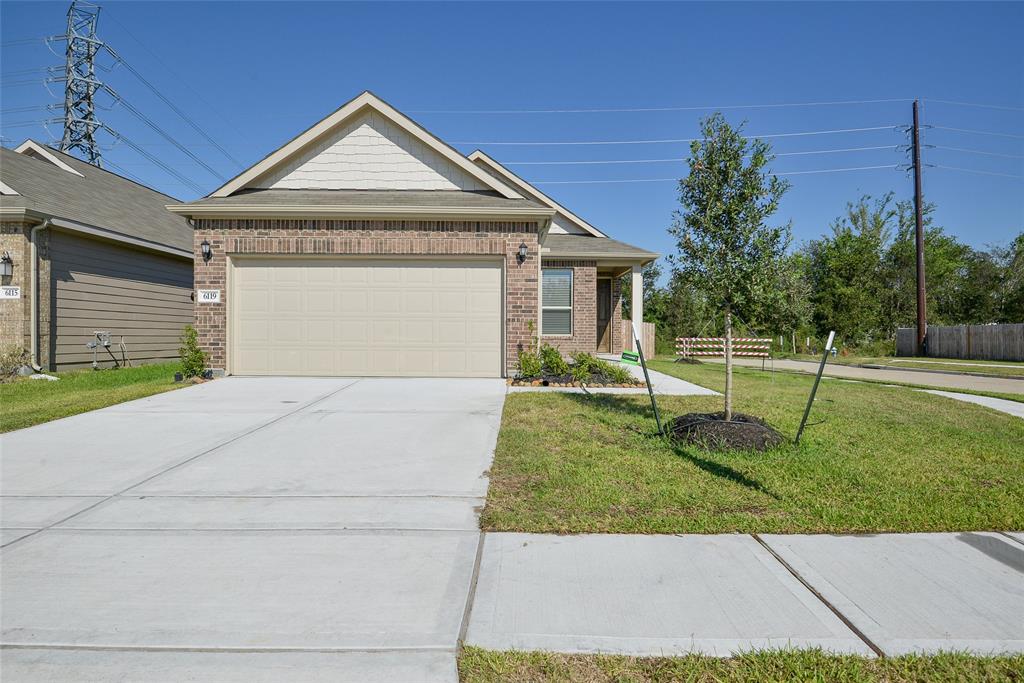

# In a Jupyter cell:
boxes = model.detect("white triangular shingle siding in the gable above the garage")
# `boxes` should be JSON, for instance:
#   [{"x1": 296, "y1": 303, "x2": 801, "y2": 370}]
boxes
[{"x1": 250, "y1": 112, "x2": 490, "y2": 190}]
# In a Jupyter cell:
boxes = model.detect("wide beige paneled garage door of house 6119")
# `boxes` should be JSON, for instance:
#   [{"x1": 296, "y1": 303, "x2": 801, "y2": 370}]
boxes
[{"x1": 228, "y1": 258, "x2": 502, "y2": 377}]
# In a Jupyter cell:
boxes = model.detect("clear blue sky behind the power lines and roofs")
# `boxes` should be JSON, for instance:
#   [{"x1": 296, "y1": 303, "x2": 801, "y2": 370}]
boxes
[{"x1": 0, "y1": 2, "x2": 1024, "y2": 266}]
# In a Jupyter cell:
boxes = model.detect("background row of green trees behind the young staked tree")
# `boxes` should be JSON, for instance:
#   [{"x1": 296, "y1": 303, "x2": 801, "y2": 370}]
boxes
[{"x1": 624, "y1": 188, "x2": 1024, "y2": 354}]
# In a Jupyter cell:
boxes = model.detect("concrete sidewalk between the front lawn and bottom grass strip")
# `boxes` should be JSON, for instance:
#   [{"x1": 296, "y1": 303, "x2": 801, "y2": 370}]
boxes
[{"x1": 466, "y1": 532, "x2": 1024, "y2": 656}]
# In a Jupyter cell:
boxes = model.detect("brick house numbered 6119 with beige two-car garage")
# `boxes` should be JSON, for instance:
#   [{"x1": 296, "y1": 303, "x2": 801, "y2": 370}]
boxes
[{"x1": 168, "y1": 92, "x2": 657, "y2": 377}]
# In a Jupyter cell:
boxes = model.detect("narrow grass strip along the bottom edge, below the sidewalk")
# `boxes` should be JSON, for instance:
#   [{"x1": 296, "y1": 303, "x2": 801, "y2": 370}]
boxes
[{"x1": 459, "y1": 647, "x2": 1024, "y2": 683}]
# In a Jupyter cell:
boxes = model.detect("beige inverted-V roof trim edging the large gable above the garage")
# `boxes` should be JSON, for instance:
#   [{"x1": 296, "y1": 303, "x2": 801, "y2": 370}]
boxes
[{"x1": 208, "y1": 90, "x2": 522, "y2": 199}]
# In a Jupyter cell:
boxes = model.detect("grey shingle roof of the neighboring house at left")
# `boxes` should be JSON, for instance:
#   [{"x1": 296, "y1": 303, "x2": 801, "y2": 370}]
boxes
[{"x1": 0, "y1": 142, "x2": 193, "y2": 253}]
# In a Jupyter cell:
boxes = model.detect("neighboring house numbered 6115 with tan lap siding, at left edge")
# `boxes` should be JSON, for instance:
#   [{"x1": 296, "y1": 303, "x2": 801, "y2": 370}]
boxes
[{"x1": 0, "y1": 140, "x2": 193, "y2": 370}]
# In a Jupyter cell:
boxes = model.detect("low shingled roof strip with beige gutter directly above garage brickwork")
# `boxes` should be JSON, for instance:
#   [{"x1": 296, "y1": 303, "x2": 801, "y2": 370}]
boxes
[{"x1": 168, "y1": 189, "x2": 554, "y2": 217}]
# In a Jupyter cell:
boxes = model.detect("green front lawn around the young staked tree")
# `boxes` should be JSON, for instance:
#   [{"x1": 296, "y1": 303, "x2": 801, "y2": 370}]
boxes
[{"x1": 481, "y1": 360, "x2": 1024, "y2": 533}]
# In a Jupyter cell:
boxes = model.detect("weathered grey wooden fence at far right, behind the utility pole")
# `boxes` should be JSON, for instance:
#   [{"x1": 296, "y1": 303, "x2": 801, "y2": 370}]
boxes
[{"x1": 896, "y1": 323, "x2": 1024, "y2": 360}]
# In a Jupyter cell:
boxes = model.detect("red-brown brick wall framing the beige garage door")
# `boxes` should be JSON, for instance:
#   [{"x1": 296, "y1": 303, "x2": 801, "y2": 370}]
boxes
[{"x1": 194, "y1": 219, "x2": 540, "y2": 374}]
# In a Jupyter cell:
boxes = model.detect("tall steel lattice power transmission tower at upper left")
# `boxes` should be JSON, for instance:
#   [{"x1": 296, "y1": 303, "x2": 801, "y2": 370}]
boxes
[{"x1": 60, "y1": 0, "x2": 105, "y2": 166}]
